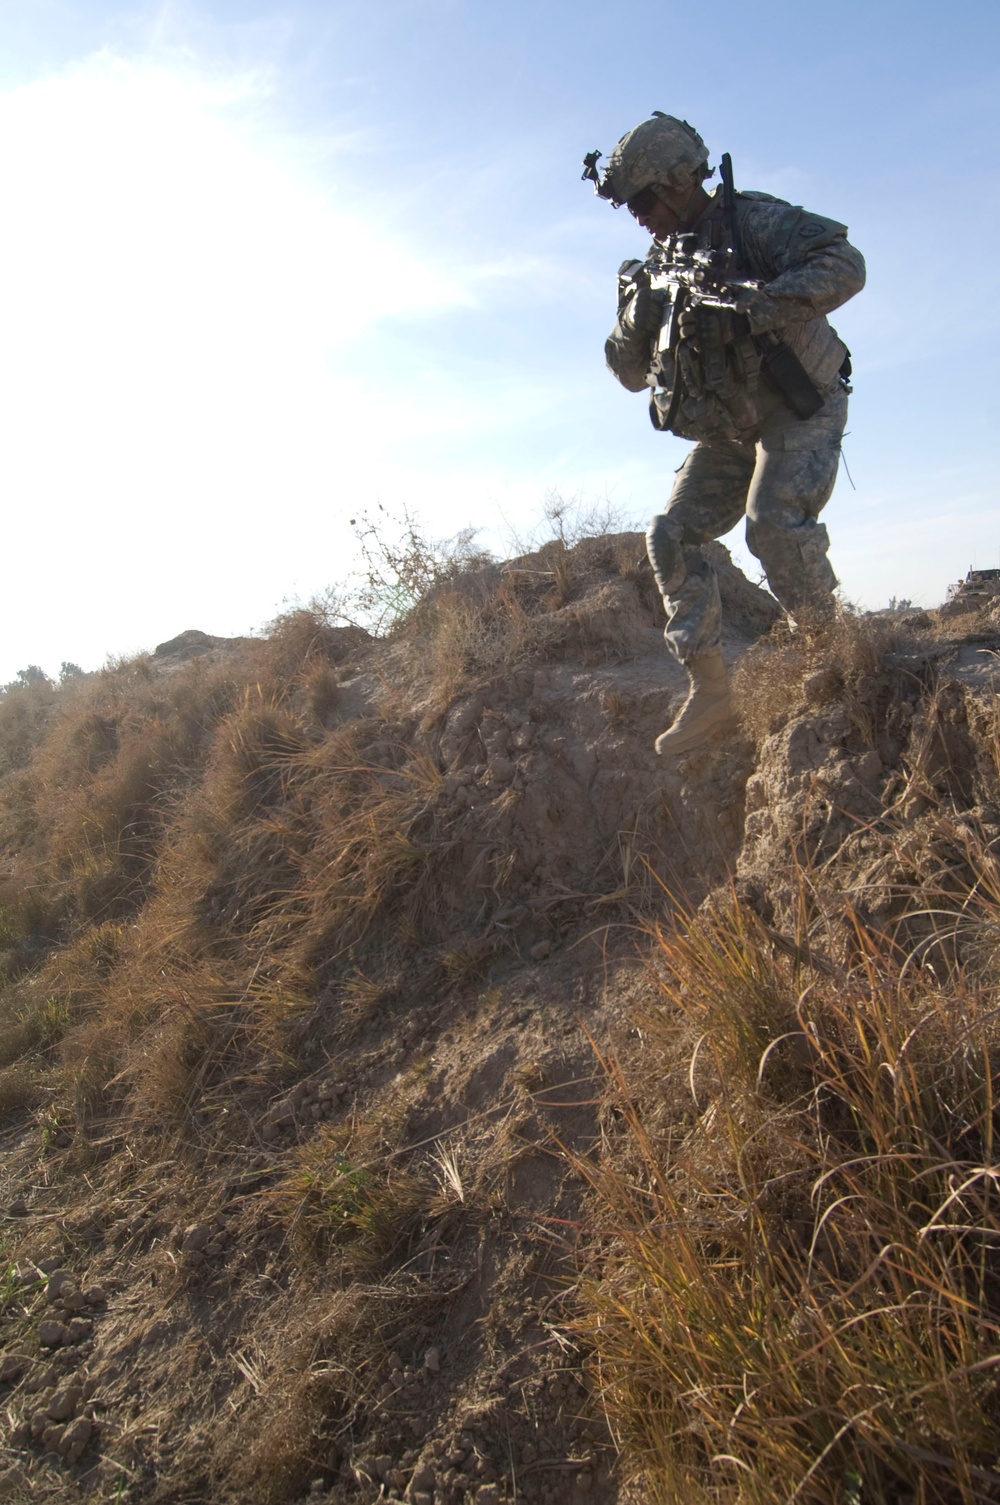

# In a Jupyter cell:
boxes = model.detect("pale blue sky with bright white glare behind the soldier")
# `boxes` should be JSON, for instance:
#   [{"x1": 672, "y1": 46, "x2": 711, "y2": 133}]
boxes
[{"x1": 0, "y1": 0, "x2": 1000, "y2": 682}]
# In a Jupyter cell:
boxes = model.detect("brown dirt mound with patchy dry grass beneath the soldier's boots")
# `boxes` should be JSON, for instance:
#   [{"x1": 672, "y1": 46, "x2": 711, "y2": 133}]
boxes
[{"x1": 0, "y1": 534, "x2": 1000, "y2": 1505}]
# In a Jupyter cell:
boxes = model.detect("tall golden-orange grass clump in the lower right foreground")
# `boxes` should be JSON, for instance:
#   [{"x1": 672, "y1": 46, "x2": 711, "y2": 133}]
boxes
[{"x1": 577, "y1": 873, "x2": 1000, "y2": 1505}]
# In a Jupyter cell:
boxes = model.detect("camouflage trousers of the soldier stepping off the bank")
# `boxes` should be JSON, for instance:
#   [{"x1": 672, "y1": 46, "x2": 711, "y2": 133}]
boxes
[{"x1": 646, "y1": 381, "x2": 848, "y2": 664}]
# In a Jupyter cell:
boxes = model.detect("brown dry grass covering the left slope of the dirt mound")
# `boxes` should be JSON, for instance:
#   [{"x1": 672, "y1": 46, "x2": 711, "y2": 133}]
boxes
[{"x1": 0, "y1": 574, "x2": 530, "y2": 1144}]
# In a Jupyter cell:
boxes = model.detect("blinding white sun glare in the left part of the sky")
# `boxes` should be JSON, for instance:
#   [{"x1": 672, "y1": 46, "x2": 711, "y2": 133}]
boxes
[{"x1": 0, "y1": 56, "x2": 468, "y2": 682}]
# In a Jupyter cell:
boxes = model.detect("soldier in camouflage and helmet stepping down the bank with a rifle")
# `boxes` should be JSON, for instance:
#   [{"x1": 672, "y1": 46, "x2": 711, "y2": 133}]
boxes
[{"x1": 584, "y1": 111, "x2": 864, "y2": 754}]
